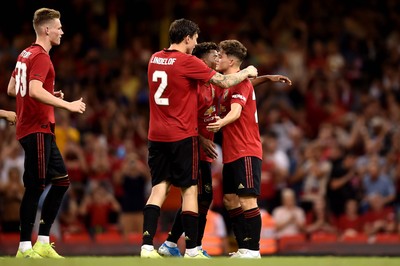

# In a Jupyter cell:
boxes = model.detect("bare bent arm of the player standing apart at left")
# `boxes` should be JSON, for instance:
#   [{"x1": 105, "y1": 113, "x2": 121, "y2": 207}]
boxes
[{"x1": 29, "y1": 79, "x2": 86, "y2": 113}]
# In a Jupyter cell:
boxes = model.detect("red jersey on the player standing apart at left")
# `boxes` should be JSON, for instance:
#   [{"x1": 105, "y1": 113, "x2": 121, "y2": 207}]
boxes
[{"x1": 12, "y1": 44, "x2": 55, "y2": 139}]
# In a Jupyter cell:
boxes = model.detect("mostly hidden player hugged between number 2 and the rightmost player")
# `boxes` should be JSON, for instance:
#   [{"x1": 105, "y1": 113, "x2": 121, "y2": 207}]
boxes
[{"x1": 158, "y1": 42, "x2": 219, "y2": 257}]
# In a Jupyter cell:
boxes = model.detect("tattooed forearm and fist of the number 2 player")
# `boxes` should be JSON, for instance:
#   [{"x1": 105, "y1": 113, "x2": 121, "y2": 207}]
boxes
[{"x1": 210, "y1": 66, "x2": 258, "y2": 88}]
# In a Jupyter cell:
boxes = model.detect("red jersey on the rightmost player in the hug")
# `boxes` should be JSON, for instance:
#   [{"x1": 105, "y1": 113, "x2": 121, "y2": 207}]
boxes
[{"x1": 222, "y1": 79, "x2": 262, "y2": 163}]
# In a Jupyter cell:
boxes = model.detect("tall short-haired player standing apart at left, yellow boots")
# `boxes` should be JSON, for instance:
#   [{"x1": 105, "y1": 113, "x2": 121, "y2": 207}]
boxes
[{"x1": 7, "y1": 8, "x2": 86, "y2": 258}]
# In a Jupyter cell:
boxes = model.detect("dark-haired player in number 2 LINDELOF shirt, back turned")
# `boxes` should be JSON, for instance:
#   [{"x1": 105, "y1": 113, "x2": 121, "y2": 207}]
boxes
[{"x1": 140, "y1": 19, "x2": 257, "y2": 258}]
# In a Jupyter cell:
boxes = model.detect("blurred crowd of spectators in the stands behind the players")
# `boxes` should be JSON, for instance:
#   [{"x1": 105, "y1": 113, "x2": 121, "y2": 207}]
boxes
[{"x1": 0, "y1": 0, "x2": 400, "y2": 244}]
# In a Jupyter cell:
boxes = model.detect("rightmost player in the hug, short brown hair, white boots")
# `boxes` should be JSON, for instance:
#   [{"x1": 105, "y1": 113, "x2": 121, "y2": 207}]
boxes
[{"x1": 207, "y1": 40, "x2": 262, "y2": 258}]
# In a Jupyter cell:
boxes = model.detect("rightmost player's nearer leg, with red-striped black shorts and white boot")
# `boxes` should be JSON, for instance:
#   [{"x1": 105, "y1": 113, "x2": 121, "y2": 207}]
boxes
[{"x1": 237, "y1": 157, "x2": 262, "y2": 258}]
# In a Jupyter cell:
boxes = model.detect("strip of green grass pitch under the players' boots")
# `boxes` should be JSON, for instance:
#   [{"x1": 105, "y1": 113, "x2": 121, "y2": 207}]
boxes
[{"x1": 0, "y1": 256, "x2": 400, "y2": 266}]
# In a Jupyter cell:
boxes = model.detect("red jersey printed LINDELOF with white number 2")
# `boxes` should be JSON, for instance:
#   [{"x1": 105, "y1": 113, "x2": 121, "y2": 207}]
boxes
[{"x1": 147, "y1": 50, "x2": 216, "y2": 142}]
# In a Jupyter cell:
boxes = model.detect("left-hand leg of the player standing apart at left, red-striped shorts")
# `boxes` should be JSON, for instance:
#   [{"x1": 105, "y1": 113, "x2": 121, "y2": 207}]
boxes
[{"x1": 17, "y1": 133, "x2": 46, "y2": 258}]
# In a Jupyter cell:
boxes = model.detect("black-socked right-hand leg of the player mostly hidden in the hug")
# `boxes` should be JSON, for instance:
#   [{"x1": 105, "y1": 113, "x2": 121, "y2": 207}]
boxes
[{"x1": 197, "y1": 161, "x2": 213, "y2": 256}]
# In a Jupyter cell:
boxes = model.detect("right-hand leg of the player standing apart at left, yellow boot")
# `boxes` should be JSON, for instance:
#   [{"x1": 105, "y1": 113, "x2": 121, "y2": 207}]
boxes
[{"x1": 33, "y1": 134, "x2": 70, "y2": 258}]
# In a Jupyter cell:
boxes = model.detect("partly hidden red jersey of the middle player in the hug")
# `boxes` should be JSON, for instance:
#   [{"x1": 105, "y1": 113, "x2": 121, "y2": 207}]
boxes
[{"x1": 197, "y1": 82, "x2": 219, "y2": 162}]
